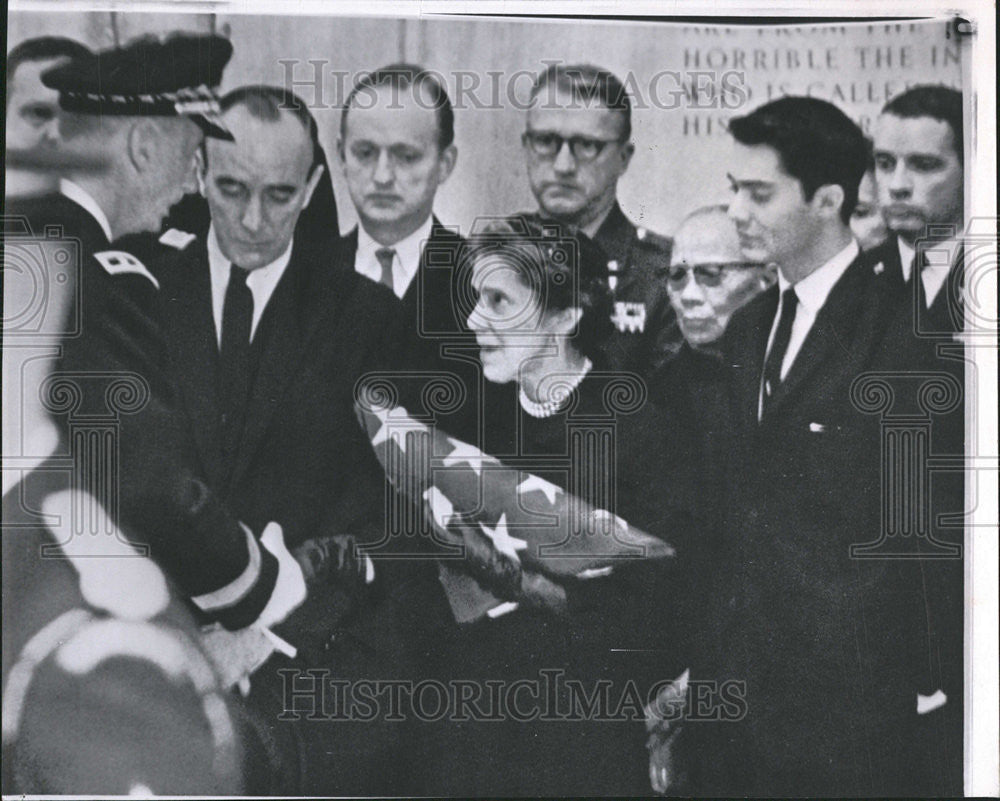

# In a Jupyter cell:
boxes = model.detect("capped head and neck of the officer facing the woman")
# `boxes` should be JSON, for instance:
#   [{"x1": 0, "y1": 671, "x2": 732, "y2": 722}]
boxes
[{"x1": 24, "y1": 34, "x2": 233, "y2": 257}]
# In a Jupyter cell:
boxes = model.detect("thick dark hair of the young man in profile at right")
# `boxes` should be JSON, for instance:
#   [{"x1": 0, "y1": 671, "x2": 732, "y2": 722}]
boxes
[{"x1": 729, "y1": 96, "x2": 868, "y2": 225}]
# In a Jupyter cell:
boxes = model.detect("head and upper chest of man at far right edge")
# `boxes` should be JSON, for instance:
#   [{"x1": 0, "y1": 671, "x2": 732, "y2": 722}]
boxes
[{"x1": 874, "y1": 86, "x2": 965, "y2": 333}]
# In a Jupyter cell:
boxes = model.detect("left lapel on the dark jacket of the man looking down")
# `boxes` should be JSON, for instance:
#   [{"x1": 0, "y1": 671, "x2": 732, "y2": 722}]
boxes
[{"x1": 164, "y1": 240, "x2": 220, "y2": 479}]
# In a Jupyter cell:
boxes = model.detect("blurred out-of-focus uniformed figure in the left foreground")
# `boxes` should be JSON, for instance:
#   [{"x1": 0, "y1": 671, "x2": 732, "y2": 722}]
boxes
[{"x1": 0, "y1": 151, "x2": 246, "y2": 797}]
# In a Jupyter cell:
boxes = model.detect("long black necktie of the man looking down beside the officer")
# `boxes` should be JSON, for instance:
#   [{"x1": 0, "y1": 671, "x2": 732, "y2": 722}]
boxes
[{"x1": 219, "y1": 264, "x2": 253, "y2": 450}]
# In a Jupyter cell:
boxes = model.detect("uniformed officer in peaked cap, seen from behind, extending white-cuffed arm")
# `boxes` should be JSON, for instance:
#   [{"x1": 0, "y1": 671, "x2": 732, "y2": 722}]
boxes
[{"x1": 23, "y1": 34, "x2": 314, "y2": 640}]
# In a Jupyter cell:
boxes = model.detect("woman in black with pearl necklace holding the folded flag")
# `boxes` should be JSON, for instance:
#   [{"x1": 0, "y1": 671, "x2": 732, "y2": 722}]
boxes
[{"x1": 410, "y1": 218, "x2": 690, "y2": 795}]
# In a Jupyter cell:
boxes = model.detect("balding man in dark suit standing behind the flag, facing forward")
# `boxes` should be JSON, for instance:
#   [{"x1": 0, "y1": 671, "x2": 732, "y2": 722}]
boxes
[{"x1": 337, "y1": 64, "x2": 480, "y2": 442}]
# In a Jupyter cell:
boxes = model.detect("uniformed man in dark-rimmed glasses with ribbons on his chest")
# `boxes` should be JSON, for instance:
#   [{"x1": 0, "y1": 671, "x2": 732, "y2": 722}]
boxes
[{"x1": 522, "y1": 64, "x2": 683, "y2": 377}]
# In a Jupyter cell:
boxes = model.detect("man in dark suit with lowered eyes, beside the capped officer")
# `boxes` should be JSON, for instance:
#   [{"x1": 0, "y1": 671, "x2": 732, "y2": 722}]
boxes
[{"x1": 154, "y1": 86, "x2": 426, "y2": 792}]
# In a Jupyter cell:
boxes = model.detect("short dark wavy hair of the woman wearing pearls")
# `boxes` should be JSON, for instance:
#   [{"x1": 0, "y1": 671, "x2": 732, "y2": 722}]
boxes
[{"x1": 461, "y1": 216, "x2": 613, "y2": 366}]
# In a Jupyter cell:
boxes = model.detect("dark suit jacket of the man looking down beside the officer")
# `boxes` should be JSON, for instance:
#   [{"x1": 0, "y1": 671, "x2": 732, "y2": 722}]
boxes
[{"x1": 155, "y1": 230, "x2": 410, "y2": 647}]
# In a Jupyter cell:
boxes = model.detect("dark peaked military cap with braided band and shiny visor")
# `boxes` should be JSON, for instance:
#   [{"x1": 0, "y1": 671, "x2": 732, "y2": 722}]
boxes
[{"x1": 42, "y1": 33, "x2": 233, "y2": 140}]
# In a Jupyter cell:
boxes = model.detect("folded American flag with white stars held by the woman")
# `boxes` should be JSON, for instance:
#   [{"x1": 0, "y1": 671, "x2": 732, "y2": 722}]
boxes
[{"x1": 356, "y1": 391, "x2": 674, "y2": 617}]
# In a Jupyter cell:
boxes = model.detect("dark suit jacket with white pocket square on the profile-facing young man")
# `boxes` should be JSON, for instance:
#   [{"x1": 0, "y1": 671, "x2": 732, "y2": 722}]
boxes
[{"x1": 694, "y1": 250, "x2": 960, "y2": 795}]
